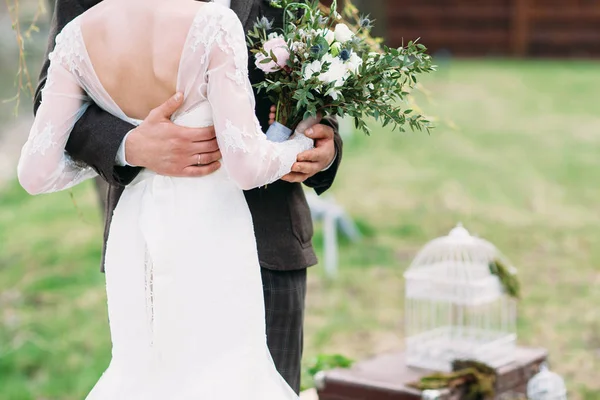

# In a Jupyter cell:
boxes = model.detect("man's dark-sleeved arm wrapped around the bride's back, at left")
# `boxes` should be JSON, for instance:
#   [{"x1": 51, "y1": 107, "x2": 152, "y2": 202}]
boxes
[{"x1": 34, "y1": 0, "x2": 140, "y2": 185}]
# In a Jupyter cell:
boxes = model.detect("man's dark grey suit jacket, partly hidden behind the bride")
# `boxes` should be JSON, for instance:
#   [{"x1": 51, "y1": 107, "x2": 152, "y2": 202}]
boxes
[{"x1": 34, "y1": 0, "x2": 342, "y2": 270}]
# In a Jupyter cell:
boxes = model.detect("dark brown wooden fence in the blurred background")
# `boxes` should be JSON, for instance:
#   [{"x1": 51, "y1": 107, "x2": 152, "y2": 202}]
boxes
[{"x1": 376, "y1": 0, "x2": 600, "y2": 57}]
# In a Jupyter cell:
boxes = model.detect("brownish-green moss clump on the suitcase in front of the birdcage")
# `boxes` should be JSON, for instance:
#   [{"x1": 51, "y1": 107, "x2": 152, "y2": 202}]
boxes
[{"x1": 408, "y1": 360, "x2": 497, "y2": 400}]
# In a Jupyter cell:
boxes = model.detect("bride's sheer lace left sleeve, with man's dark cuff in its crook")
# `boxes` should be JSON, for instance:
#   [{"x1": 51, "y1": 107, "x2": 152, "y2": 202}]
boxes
[{"x1": 18, "y1": 39, "x2": 96, "y2": 194}]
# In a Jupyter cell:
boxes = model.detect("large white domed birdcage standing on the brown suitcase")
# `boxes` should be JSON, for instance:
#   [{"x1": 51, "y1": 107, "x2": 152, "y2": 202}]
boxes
[{"x1": 404, "y1": 225, "x2": 517, "y2": 371}]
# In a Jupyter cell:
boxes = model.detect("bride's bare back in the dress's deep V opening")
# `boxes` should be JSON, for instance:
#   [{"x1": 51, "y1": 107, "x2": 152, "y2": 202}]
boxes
[{"x1": 81, "y1": 0, "x2": 205, "y2": 119}]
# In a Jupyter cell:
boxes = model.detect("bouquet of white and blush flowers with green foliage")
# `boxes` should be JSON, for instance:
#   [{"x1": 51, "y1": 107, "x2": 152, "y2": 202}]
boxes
[{"x1": 248, "y1": 0, "x2": 435, "y2": 134}]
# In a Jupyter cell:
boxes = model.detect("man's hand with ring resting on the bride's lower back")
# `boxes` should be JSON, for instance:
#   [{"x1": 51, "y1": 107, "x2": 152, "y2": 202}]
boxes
[{"x1": 125, "y1": 93, "x2": 221, "y2": 177}]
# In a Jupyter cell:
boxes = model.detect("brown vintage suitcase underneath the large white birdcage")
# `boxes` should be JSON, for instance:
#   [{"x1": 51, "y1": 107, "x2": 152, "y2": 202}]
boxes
[{"x1": 316, "y1": 347, "x2": 547, "y2": 400}]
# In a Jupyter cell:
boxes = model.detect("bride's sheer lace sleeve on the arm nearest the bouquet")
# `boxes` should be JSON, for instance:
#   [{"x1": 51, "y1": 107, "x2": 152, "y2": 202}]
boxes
[{"x1": 207, "y1": 10, "x2": 313, "y2": 190}]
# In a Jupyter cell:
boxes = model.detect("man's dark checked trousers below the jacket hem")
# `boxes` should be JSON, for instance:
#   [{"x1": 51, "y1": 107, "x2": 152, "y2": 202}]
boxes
[{"x1": 261, "y1": 268, "x2": 306, "y2": 393}]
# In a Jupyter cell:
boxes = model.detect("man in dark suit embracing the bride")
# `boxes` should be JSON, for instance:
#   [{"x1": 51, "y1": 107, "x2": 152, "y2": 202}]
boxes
[{"x1": 34, "y1": 0, "x2": 342, "y2": 392}]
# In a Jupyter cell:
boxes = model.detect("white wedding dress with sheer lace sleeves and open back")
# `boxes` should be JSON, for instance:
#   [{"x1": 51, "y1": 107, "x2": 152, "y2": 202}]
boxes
[{"x1": 19, "y1": 3, "x2": 312, "y2": 400}]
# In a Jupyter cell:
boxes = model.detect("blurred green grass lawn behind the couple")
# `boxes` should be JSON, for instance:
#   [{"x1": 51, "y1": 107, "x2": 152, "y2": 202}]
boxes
[{"x1": 0, "y1": 61, "x2": 600, "y2": 400}]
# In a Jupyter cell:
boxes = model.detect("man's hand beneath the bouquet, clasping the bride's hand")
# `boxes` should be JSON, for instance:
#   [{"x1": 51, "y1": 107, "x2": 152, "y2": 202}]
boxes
[{"x1": 281, "y1": 124, "x2": 335, "y2": 182}]
